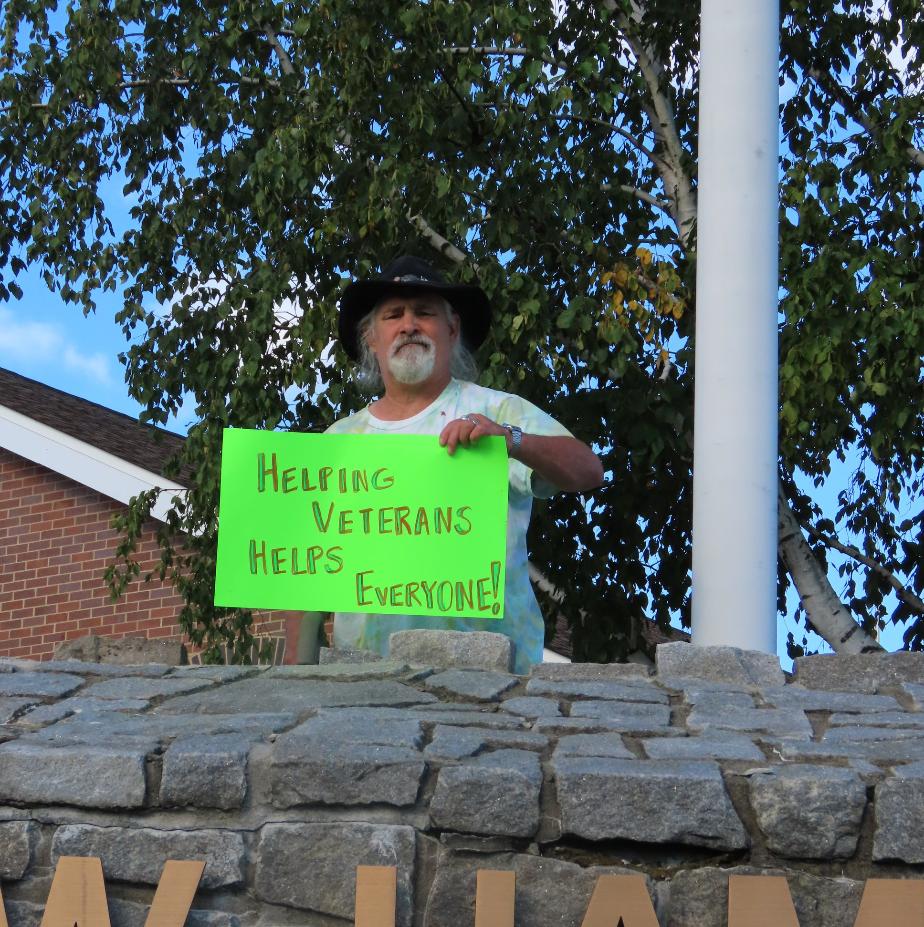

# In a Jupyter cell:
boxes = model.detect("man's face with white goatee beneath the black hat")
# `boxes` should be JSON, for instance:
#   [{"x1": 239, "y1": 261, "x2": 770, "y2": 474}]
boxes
[{"x1": 369, "y1": 293, "x2": 459, "y2": 386}]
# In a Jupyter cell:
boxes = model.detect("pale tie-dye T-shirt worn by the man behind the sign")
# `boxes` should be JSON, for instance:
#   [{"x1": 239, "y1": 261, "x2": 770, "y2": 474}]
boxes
[{"x1": 328, "y1": 380, "x2": 570, "y2": 673}]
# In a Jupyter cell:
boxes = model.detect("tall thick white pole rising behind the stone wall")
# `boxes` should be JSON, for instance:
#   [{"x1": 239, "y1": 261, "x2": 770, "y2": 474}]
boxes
[{"x1": 693, "y1": 0, "x2": 779, "y2": 653}]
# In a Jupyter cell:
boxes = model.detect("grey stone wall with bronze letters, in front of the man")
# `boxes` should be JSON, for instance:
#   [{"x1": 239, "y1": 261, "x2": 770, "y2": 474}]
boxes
[{"x1": 0, "y1": 632, "x2": 924, "y2": 927}]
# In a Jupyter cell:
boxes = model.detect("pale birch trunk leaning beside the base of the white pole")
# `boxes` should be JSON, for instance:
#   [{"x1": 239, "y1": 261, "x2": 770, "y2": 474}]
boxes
[{"x1": 779, "y1": 483, "x2": 883, "y2": 653}]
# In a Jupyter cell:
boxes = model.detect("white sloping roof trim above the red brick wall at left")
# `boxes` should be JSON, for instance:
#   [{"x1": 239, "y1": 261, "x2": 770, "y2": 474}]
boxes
[{"x1": 0, "y1": 405, "x2": 185, "y2": 521}]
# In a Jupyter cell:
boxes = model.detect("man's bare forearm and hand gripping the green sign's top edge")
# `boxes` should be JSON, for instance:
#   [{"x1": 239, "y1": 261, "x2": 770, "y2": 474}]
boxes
[{"x1": 440, "y1": 413, "x2": 603, "y2": 492}]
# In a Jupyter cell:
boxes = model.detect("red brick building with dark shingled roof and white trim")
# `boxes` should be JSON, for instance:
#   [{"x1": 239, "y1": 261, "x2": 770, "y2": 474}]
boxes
[{"x1": 0, "y1": 369, "x2": 293, "y2": 660}]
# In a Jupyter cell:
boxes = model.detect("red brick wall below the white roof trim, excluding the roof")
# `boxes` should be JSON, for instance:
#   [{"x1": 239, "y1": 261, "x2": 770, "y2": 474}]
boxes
[{"x1": 0, "y1": 448, "x2": 287, "y2": 660}]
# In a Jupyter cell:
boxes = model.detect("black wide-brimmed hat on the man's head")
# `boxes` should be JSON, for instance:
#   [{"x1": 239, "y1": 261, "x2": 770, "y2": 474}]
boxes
[{"x1": 337, "y1": 255, "x2": 491, "y2": 360}]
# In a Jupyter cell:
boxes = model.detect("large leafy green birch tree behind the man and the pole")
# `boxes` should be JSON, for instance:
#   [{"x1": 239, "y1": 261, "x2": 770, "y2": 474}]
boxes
[{"x1": 0, "y1": 0, "x2": 924, "y2": 659}]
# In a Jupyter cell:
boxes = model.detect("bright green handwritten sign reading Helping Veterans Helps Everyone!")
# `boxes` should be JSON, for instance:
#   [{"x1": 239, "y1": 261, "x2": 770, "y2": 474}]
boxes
[{"x1": 215, "y1": 428, "x2": 507, "y2": 618}]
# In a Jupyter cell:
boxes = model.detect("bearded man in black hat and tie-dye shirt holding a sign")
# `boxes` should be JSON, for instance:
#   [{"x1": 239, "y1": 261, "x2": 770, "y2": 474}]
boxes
[{"x1": 329, "y1": 257, "x2": 603, "y2": 673}]
